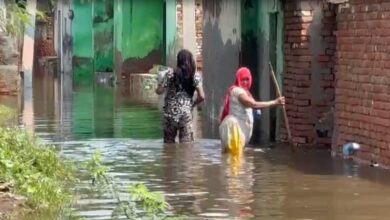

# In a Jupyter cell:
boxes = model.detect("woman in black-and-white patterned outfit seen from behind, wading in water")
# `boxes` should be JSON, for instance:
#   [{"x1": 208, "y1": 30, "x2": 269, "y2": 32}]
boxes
[{"x1": 156, "y1": 49, "x2": 204, "y2": 143}]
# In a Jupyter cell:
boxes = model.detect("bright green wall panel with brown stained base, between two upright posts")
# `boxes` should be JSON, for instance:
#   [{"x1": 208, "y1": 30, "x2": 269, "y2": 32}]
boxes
[{"x1": 114, "y1": 0, "x2": 165, "y2": 73}]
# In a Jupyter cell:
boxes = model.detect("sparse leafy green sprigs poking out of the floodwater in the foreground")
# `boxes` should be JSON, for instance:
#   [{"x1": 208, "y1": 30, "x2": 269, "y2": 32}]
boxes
[{"x1": 85, "y1": 151, "x2": 183, "y2": 219}]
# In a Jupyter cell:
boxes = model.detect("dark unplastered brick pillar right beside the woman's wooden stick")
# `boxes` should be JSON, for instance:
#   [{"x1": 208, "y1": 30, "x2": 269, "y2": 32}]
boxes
[{"x1": 284, "y1": 0, "x2": 336, "y2": 147}]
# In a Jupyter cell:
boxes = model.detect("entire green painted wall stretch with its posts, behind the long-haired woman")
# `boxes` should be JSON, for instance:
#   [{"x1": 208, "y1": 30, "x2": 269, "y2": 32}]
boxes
[{"x1": 72, "y1": 0, "x2": 169, "y2": 85}]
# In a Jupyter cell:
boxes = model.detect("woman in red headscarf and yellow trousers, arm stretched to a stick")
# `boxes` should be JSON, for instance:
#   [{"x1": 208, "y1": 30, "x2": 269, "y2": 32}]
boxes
[{"x1": 219, "y1": 67, "x2": 285, "y2": 152}]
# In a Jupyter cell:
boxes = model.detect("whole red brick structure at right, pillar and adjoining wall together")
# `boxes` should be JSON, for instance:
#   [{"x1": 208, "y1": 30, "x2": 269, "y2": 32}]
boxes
[{"x1": 284, "y1": 0, "x2": 390, "y2": 166}]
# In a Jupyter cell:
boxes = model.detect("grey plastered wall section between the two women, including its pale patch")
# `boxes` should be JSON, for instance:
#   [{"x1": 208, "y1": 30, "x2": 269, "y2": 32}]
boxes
[{"x1": 202, "y1": 0, "x2": 241, "y2": 138}]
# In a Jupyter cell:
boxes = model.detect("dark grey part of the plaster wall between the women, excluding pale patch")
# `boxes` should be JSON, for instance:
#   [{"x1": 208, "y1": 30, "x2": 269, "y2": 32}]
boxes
[{"x1": 202, "y1": 1, "x2": 241, "y2": 138}]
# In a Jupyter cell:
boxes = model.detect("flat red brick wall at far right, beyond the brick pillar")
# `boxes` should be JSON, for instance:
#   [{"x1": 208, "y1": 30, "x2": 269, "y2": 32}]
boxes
[{"x1": 333, "y1": 0, "x2": 390, "y2": 166}]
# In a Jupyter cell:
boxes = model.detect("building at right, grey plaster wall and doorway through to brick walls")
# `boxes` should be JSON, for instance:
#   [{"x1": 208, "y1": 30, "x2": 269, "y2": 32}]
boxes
[{"x1": 202, "y1": 0, "x2": 390, "y2": 165}]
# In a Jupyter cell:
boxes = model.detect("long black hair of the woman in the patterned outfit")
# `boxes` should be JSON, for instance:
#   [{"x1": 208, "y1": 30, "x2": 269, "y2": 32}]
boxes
[{"x1": 174, "y1": 49, "x2": 196, "y2": 96}]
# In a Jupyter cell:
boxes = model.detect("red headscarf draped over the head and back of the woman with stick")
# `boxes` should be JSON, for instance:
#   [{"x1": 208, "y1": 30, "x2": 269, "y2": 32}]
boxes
[{"x1": 220, "y1": 67, "x2": 252, "y2": 122}]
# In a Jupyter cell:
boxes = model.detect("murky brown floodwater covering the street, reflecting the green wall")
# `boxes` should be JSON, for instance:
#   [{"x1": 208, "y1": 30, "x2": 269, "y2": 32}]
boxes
[{"x1": 0, "y1": 71, "x2": 390, "y2": 220}]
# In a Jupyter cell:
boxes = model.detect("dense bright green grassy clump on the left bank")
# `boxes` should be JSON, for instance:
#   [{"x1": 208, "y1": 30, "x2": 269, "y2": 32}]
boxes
[{"x1": 0, "y1": 128, "x2": 76, "y2": 208}]
